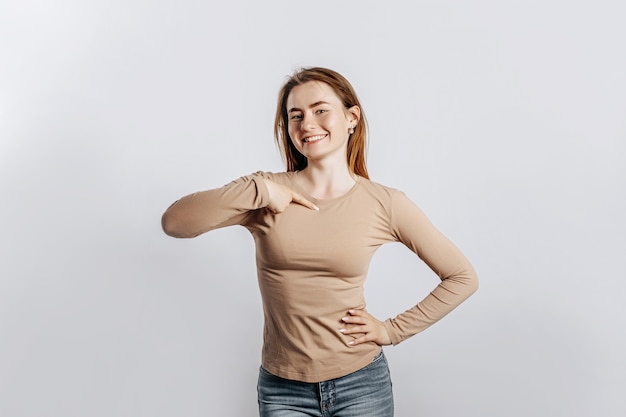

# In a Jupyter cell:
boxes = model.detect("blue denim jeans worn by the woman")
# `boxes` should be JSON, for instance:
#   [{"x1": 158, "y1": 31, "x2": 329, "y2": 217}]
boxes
[{"x1": 257, "y1": 352, "x2": 393, "y2": 417}]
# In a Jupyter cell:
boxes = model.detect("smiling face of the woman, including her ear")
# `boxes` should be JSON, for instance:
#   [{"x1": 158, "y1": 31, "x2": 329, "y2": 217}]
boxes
[{"x1": 286, "y1": 81, "x2": 360, "y2": 164}]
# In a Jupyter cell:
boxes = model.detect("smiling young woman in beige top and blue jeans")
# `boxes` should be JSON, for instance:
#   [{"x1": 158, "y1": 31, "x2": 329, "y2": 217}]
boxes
[{"x1": 162, "y1": 68, "x2": 478, "y2": 417}]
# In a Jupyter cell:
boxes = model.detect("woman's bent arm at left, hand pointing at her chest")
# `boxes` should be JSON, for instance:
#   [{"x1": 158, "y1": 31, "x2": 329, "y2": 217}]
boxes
[{"x1": 161, "y1": 174, "x2": 317, "y2": 238}]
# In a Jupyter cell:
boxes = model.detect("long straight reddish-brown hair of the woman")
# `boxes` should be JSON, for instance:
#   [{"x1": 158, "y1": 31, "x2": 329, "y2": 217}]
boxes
[{"x1": 274, "y1": 67, "x2": 369, "y2": 179}]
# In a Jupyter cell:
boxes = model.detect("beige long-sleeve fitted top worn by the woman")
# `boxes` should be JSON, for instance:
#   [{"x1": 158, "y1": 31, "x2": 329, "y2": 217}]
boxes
[{"x1": 163, "y1": 172, "x2": 478, "y2": 382}]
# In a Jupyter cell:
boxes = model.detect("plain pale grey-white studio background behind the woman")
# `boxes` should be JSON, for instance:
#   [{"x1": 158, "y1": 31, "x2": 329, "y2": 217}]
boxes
[{"x1": 0, "y1": 0, "x2": 626, "y2": 417}]
